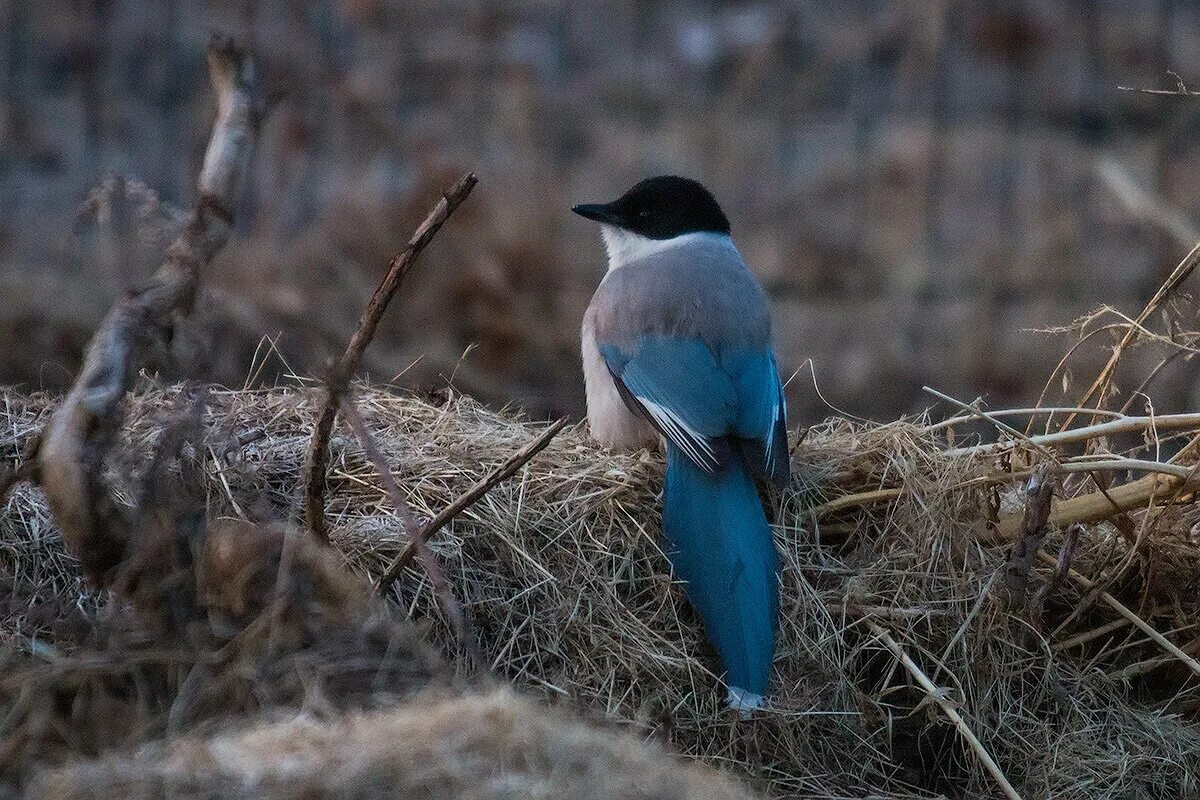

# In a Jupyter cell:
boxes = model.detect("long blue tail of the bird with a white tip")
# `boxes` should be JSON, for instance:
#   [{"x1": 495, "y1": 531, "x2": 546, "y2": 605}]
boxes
[{"x1": 662, "y1": 443, "x2": 779, "y2": 710}]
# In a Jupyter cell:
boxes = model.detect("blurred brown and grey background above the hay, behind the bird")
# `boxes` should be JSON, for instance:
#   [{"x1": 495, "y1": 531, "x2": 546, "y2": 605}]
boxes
[{"x1": 0, "y1": 0, "x2": 1200, "y2": 422}]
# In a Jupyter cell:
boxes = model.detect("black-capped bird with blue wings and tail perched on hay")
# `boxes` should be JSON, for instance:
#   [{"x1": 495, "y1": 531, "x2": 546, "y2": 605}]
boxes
[{"x1": 571, "y1": 175, "x2": 791, "y2": 716}]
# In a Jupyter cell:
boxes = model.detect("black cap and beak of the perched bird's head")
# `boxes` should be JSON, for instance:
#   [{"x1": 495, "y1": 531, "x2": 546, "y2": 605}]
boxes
[{"x1": 571, "y1": 175, "x2": 730, "y2": 239}]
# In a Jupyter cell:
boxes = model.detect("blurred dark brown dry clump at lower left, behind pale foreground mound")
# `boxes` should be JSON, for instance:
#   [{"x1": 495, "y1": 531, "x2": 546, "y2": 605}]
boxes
[{"x1": 0, "y1": 521, "x2": 456, "y2": 796}]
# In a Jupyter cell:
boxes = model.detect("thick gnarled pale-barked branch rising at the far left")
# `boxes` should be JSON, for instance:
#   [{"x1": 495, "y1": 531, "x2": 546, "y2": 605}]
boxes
[{"x1": 38, "y1": 36, "x2": 258, "y2": 585}]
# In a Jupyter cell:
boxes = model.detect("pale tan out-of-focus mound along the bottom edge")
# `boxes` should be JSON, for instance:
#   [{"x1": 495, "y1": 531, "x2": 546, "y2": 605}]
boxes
[{"x1": 30, "y1": 691, "x2": 749, "y2": 800}]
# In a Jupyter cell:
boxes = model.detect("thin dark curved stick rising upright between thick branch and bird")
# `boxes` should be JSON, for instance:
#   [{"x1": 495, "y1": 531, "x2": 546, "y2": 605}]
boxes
[{"x1": 305, "y1": 173, "x2": 479, "y2": 542}]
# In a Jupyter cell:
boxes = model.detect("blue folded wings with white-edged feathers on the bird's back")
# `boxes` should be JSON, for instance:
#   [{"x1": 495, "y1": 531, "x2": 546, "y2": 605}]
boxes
[{"x1": 599, "y1": 336, "x2": 788, "y2": 483}]
